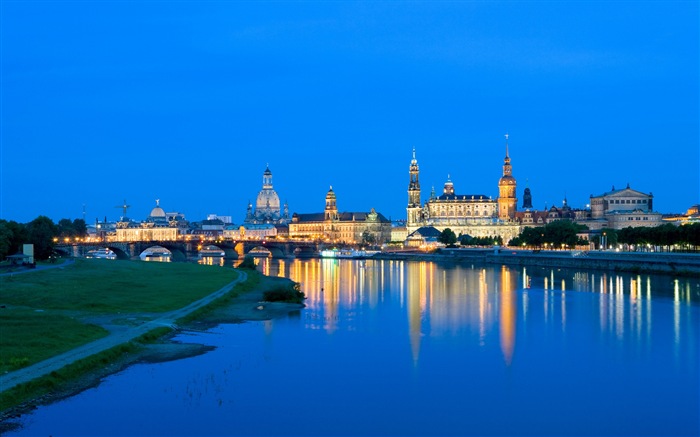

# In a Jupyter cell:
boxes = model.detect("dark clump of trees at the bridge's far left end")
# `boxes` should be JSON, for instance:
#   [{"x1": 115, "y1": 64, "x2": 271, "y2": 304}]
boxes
[{"x1": 0, "y1": 215, "x2": 87, "y2": 260}]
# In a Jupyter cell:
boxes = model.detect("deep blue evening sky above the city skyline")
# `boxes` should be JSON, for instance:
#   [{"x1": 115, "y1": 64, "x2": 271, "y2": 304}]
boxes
[{"x1": 0, "y1": 0, "x2": 700, "y2": 223}]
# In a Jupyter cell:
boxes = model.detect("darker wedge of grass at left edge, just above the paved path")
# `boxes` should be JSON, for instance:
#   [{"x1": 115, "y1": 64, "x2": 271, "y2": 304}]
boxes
[{"x1": 0, "y1": 308, "x2": 108, "y2": 372}]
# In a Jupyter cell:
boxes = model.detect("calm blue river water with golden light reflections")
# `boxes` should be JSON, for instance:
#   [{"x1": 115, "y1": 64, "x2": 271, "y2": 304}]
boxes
[{"x1": 9, "y1": 260, "x2": 700, "y2": 436}]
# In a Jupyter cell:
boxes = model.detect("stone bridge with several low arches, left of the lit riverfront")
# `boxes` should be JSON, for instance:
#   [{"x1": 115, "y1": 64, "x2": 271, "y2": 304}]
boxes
[{"x1": 54, "y1": 240, "x2": 323, "y2": 261}]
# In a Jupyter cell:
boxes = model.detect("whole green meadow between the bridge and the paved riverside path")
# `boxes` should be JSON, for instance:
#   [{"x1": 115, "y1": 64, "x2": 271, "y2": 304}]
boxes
[{"x1": 0, "y1": 259, "x2": 237, "y2": 372}]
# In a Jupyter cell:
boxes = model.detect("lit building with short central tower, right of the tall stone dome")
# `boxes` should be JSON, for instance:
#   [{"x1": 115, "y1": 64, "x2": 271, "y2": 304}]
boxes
[{"x1": 289, "y1": 187, "x2": 391, "y2": 245}]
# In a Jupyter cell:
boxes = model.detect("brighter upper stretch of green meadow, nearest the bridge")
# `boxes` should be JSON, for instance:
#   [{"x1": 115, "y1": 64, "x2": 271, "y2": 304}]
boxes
[{"x1": 0, "y1": 259, "x2": 238, "y2": 313}]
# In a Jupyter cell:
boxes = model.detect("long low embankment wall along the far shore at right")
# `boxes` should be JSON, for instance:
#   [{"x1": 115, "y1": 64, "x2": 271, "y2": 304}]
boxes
[{"x1": 372, "y1": 248, "x2": 700, "y2": 275}]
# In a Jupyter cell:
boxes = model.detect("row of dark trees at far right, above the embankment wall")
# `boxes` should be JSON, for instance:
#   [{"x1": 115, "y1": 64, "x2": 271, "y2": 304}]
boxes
[{"x1": 593, "y1": 223, "x2": 700, "y2": 251}]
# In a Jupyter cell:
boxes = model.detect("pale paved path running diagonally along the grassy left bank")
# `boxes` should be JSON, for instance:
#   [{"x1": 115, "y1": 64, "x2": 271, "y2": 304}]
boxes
[{"x1": 0, "y1": 271, "x2": 248, "y2": 393}]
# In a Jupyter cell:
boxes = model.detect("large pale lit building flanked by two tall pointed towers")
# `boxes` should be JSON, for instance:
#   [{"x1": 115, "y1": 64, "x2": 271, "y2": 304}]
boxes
[{"x1": 406, "y1": 135, "x2": 520, "y2": 242}]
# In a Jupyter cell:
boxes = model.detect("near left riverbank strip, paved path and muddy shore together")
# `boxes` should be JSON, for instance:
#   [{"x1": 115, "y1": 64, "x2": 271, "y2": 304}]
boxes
[{"x1": 0, "y1": 265, "x2": 303, "y2": 432}]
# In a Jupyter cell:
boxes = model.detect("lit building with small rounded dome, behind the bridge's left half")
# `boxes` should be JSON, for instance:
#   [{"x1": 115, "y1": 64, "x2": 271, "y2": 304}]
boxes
[{"x1": 107, "y1": 200, "x2": 188, "y2": 242}]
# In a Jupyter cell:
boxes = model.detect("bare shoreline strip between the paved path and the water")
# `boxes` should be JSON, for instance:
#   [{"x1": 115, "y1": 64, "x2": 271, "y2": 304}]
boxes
[{"x1": 0, "y1": 276, "x2": 304, "y2": 434}]
